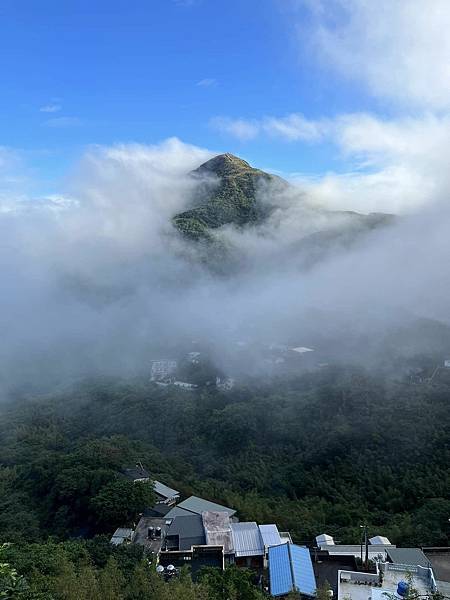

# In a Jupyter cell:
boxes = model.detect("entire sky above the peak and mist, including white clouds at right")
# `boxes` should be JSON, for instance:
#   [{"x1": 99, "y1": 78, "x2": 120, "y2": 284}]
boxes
[{"x1": 0, "y1": 0, "x2": 450, "y2": 211}]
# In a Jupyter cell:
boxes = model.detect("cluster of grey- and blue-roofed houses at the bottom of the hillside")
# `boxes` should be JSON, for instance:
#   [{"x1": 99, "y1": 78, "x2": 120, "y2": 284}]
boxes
[{"x1": 111, "y1": 464, "x2": 450, "y2": 600}]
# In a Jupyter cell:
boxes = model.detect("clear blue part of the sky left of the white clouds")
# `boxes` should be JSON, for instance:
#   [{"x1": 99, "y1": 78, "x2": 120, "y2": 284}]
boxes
[{"x1": 0, "y1": 0, "x2": 384, "y2": 191}]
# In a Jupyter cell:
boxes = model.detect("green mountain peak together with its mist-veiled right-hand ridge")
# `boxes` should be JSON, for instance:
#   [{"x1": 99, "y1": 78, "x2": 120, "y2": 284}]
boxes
[{"x1": 173, "y1": 153, "x2": 394, "y2": 271}]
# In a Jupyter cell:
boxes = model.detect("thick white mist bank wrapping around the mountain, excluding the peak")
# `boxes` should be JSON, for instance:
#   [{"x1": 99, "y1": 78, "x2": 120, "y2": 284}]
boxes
[{"x1": 0, "y1": 137, "x2": 450, "y2": 392}]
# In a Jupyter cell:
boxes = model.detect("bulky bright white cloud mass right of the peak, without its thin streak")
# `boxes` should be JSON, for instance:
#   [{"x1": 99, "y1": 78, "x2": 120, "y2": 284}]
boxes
[{"x1": 315, "y1": 114, "x2": 450, "y2": 212}]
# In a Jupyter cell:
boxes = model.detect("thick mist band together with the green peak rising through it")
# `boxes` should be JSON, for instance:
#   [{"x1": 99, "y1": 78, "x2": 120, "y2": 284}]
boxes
[{"x1": 0, "y1": 139, "x2": 450, "y2": 390}]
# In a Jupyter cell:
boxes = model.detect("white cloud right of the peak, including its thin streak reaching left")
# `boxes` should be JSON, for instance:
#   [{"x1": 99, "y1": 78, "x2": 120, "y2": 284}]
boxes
[{"x1": 213, "y1": 113, "x2": 450, "y2": 212}]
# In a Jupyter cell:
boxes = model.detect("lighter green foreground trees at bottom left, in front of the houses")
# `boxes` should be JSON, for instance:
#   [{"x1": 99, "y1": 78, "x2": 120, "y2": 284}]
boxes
[{"x1": 0, "y1": 537, "x2": 268, "y2": 600}]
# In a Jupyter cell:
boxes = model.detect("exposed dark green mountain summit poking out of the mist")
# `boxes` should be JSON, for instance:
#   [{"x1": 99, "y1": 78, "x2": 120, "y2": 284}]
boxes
[{"x1": 173, "y1": 154, "x2": 289, "y2": 240}]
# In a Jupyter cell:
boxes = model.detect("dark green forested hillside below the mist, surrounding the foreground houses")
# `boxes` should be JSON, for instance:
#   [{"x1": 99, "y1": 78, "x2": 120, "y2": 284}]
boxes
[{"x1": 0, "y1": 369, "x2": 450, "y2": 599}]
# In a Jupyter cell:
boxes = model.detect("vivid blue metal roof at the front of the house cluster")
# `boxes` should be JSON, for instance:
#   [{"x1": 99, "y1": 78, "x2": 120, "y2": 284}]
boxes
[{"x1": 269, "y1": 544, "x2": 316, "y2": 596}]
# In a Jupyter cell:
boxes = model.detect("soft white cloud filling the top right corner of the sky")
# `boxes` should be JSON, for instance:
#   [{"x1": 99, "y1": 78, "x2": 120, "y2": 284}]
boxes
[{"x1": 299, "y1": 0, "x2": 450, "y2": 110}]
